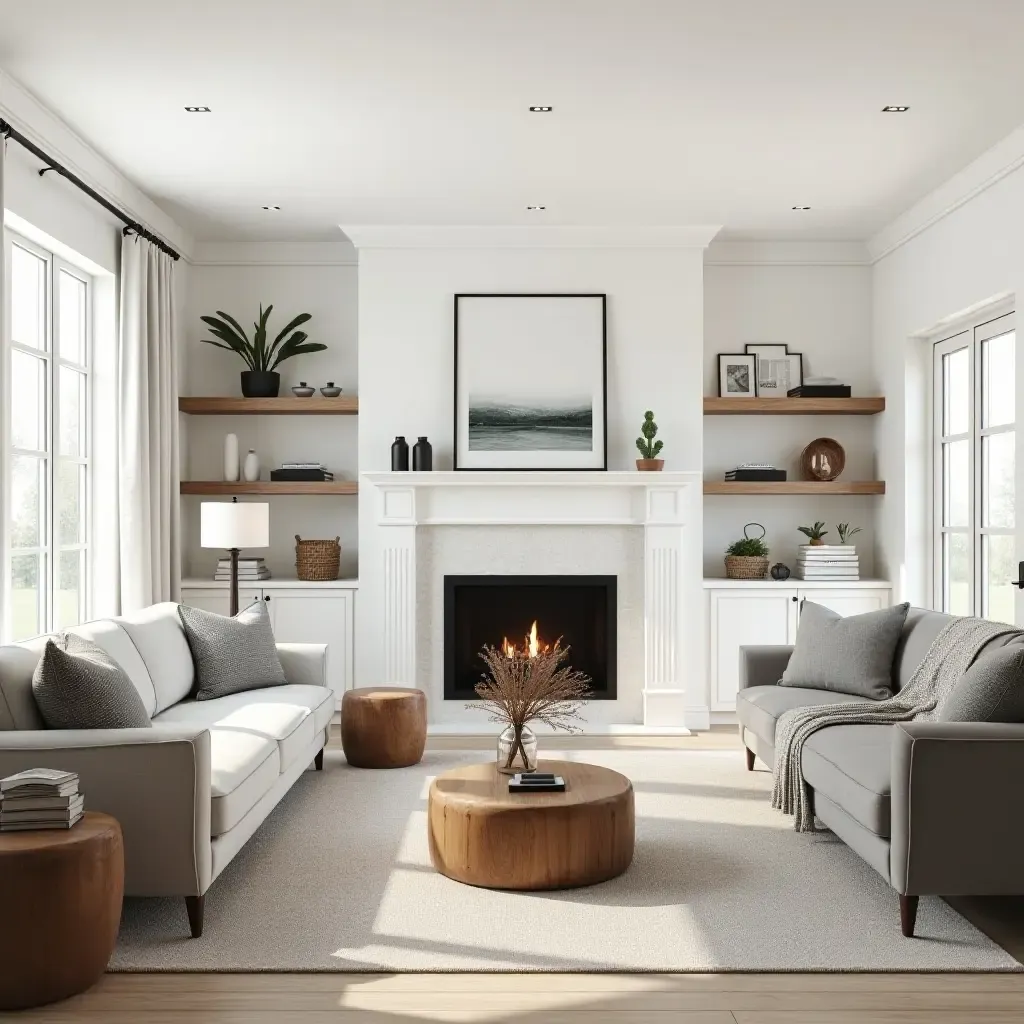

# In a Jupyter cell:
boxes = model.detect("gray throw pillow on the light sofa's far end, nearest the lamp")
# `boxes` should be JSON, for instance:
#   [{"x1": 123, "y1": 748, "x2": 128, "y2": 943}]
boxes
[{"x1": 178, "y1": 601, "x2": 288, "y2": 700}]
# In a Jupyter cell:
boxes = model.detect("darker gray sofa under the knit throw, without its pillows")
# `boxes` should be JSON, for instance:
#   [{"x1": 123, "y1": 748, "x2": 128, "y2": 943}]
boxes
[{"x1": 736, "y1": 608, "x2": 1024, "y2": 936}]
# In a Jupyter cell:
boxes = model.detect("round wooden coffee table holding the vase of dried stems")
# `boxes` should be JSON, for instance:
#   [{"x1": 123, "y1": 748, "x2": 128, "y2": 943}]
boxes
[{"x1": 427, "y1": 761, "x2": 634, "y2": 889}]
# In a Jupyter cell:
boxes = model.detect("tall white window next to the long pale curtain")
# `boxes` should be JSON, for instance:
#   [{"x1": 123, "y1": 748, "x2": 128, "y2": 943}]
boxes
[{"x1": 0, "y1": 232, "x2": 92, "y2": 641}]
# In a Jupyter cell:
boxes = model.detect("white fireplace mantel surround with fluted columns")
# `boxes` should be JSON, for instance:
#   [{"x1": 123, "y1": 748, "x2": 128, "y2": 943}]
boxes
[{"x1": 361, "y1": 471, "x2": 709, "y2": 733}]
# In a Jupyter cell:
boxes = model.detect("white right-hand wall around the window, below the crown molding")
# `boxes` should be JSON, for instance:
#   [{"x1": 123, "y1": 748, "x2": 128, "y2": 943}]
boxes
[{"x1": 873, "y1": 169, "x2": 1024, "y2": 606}]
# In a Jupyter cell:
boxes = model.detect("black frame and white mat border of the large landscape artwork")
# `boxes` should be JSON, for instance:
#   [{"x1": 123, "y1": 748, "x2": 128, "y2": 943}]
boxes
[{"x1": 452, "y1": 292, "x2": 608, "y2": 472}]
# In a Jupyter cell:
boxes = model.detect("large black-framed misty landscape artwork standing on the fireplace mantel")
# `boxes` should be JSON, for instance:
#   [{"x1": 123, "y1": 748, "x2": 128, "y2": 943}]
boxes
[{"x1": 455, "y1": 294, "x2": 608, "y2": 470}]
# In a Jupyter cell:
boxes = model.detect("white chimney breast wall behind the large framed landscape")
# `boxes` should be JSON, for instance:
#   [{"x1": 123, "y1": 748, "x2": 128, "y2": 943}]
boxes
[{"x1": 355, "y1": 229, "x2": 703, "y2": 681}]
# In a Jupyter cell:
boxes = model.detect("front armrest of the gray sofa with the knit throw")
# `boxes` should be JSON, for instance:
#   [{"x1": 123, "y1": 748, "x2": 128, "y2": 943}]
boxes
[{"x1": 890, "y1": 722, "x2": 1024, "y2": 896}]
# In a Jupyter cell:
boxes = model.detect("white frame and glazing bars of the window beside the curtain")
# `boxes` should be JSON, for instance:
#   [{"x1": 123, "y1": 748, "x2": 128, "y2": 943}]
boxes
[{"x1": 0, "y1": 228, "x2": 94, "y2": 642}]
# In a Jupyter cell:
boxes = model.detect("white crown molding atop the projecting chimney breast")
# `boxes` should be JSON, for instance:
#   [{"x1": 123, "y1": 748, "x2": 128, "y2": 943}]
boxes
[{"x1": 341, "y1": 224, "x2": 721, "y2": 249}]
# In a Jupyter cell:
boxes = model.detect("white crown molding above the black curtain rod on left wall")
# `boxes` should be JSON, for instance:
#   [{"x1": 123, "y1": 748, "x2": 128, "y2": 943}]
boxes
[{"x1": 0, "y1": 70, "x2": 193, "y2": 259}]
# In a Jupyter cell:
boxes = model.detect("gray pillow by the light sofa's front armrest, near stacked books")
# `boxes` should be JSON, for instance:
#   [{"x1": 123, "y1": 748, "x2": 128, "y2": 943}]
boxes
[{"x1": 32, "y1": 633, "x2": 153, "y2": 729}]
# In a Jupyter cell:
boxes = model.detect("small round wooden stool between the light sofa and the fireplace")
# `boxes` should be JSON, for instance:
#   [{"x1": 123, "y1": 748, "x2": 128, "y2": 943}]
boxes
[{"x1": 341, "y1": 686, "x2": 427, "y2": 768}]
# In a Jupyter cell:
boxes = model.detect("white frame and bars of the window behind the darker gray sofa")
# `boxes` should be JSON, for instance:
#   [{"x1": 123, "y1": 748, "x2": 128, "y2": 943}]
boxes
[{"x1": 930, "y1": 305, "x2": 1020, "y2": 616}]
